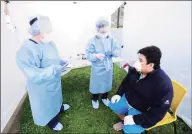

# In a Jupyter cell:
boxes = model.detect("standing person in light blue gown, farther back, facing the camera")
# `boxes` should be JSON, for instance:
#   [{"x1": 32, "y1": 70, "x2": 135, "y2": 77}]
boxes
[{"x1": 86, "y1": 17, "x2": 120, "y2": 109}]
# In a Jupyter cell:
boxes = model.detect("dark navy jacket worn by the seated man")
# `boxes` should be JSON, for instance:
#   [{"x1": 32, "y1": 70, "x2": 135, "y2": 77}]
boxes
[{"x1": 117, "y1": 67, "x2": 173, "y2": 128}]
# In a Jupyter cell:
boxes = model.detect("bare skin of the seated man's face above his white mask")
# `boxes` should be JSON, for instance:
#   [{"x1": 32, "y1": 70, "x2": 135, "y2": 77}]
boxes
[{"x1": 139, "y1": 54, "x2": 154, "y2": 73}]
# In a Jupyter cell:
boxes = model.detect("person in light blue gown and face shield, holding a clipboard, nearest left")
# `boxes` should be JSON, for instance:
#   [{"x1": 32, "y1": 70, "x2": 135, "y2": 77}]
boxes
[{"x1": 16, "y1": 16, "x2": 70, "y2": 131}]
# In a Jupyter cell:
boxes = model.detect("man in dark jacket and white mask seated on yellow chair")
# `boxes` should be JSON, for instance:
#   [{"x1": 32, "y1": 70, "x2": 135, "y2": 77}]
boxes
[{"x1": 109, "y1": 46, "x2": 173, "y2": 133}]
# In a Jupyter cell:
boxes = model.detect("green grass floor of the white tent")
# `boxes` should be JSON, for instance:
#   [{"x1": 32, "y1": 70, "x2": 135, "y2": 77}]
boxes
[{"x1": 19, "y1": 66, "x2": 192, "y2": 134}]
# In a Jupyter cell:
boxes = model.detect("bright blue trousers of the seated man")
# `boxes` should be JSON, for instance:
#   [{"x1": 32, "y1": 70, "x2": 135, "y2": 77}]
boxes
[{"x1": 109, "y1": 94, "x2": 145, "y2": 134}]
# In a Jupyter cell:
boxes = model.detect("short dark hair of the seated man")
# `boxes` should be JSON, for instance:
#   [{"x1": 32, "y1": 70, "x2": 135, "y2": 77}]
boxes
[{"x1": 138, "y1": 46, "x2": 162, "y2": 69}]
